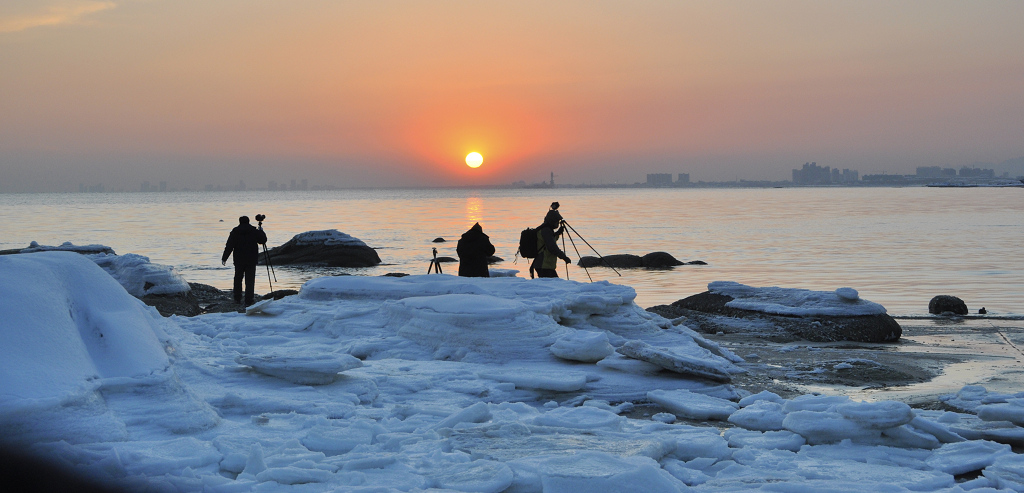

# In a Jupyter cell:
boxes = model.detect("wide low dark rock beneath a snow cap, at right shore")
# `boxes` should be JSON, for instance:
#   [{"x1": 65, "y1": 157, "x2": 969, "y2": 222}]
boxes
[{"x1": 647, "y1": 291, "x2": 903, "y2": 342}]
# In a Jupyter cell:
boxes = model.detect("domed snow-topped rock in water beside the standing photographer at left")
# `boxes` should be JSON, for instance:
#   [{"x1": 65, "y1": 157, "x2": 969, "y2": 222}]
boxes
[{"x1": 259, "y1": 230, "x2": 381, "y2": 268}]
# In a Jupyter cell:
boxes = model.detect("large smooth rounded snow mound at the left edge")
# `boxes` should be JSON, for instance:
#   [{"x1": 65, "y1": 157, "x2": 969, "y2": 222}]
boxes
[{"x1": 0, "y1": 251, "x2": 170, "y2": 412}]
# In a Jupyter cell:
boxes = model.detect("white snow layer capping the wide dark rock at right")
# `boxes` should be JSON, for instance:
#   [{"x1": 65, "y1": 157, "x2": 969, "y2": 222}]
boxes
[{"x1": 708, "y1": 281, "x2": 886, "y2": 317}]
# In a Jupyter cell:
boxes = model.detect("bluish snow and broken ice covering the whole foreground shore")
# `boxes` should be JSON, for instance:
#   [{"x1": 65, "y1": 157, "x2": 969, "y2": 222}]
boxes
[{"x1": 0, "y1": 252, "x2": 1024, "y2": 493}]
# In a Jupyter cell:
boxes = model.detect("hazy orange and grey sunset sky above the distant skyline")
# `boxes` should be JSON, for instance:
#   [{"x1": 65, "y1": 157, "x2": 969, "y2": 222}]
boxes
[{"x1": 0, "y1": 0, "x2": 1024, "y2": 192}]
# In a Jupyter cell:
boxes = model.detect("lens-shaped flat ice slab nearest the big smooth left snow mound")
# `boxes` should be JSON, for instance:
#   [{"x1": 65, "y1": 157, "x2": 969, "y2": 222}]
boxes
[{"x1": 234, "y1": 354, "x2": 362, "y2": 385}]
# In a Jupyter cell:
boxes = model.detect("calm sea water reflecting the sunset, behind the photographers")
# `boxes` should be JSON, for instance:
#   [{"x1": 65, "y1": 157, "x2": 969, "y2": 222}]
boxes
[{"x1": 0, "y1": 188, "x2": 1024, "y2": 315}]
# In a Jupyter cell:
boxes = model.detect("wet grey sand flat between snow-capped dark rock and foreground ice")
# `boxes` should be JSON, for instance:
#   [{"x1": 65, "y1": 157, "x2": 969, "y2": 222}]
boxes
[{"x1": 706, "y1": 318, "x2": 1024, "y2": 409}]
